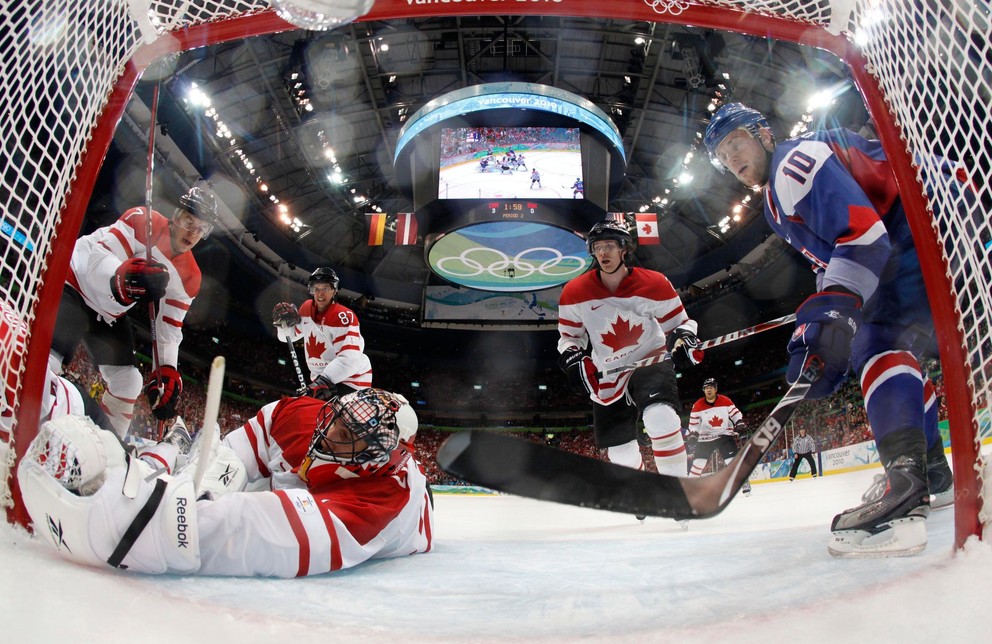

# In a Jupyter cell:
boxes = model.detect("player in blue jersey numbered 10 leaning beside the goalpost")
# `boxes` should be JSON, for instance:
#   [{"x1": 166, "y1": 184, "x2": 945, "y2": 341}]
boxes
[{"x1": 704, "y1": 103, "x2": 953, "y2": 557}]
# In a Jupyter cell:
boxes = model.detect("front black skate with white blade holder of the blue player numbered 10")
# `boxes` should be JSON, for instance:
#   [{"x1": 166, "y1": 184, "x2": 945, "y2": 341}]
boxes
[{"x1": 827, "y1": 430, "x2": 930, "y2": 557}]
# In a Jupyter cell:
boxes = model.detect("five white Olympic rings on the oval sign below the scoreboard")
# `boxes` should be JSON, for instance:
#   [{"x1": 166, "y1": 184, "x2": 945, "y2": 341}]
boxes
[{"x1": 435, "y1": 246, "x2": 588, "y2": 280}]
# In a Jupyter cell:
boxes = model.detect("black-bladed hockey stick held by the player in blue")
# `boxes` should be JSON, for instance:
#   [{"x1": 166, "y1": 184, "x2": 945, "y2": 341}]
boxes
[{"x1": 437, "y1": 359, "x2": 822, "y2": 520}]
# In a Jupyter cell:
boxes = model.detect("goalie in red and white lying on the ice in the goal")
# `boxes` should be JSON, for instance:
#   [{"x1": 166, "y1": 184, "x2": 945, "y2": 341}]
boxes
[{"x1": 18, "y1": 388, "x2": 433, "y2": 577}]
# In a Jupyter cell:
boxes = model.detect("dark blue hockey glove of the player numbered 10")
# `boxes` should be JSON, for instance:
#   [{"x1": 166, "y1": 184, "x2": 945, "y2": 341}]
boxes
[{"x1": 785, "y1": 291, "x2": 861, "y2": 400}]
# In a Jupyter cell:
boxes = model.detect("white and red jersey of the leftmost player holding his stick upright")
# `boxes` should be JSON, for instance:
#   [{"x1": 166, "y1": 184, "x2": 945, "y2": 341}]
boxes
[{"x1": 66, "y1": 208, "x2": 201, "y2": 365}]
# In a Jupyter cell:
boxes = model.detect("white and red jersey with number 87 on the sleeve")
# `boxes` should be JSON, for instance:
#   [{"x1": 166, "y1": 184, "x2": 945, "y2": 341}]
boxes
[{"x1": 277, "y1": 300, "x2": 372, "y2": 389}]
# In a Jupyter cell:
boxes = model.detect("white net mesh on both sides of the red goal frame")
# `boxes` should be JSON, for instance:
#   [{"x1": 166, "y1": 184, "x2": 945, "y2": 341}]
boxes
[{"x1": 0, "y1": 0, "x2": 992, "y2": 540}]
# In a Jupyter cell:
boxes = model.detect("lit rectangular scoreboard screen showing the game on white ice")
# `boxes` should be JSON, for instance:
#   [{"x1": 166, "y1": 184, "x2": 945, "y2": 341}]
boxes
[{"x1": 438, "y1": 126, "x2": 584, "y2": 199}]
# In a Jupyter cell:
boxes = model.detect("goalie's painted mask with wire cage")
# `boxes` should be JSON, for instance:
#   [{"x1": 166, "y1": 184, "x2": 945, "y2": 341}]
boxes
[{"x1": 307, "y1": 387, "x2": 417, "y2": 465}]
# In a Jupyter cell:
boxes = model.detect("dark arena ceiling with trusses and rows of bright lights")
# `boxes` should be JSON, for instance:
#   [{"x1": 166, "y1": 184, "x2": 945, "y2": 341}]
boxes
[{"x1": 88, "y1": 16, "x2": 867, "y2": 340}]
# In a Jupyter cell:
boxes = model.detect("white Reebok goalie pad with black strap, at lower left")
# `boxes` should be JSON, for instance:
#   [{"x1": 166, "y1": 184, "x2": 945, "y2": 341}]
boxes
[{"x1": 17, "y1": 419, "x2": 200, "y2": 573}]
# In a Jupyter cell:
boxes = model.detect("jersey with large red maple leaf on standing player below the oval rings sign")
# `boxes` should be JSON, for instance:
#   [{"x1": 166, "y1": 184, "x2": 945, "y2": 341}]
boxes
[{"x1": 558, "y1": 268, "x2": 696, "y2": 405}]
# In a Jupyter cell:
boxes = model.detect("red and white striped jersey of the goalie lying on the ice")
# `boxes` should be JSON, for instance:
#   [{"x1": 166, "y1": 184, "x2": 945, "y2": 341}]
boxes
[{"x1": 197, "y1": 396, "x2": 434, "y2": 577}]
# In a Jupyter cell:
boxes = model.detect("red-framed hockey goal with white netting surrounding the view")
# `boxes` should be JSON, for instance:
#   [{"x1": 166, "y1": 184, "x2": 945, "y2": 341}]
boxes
[{"x1": 0, "y1": 0, "x2": 992, "y2": 545}]
